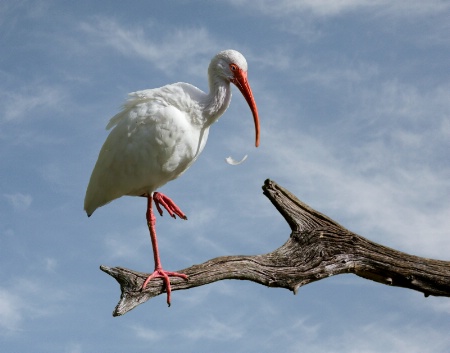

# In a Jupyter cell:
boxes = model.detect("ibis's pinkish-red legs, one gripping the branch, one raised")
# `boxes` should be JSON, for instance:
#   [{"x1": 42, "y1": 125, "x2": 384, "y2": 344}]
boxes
[{"x1": 142, "y1": 193, "x2": 188, "y2": 306}]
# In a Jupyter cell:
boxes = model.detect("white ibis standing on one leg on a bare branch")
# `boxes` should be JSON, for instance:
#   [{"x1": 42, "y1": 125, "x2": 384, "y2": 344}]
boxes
[{"x1": 84, "y1": 50, "x2": 259, "y2": 306}]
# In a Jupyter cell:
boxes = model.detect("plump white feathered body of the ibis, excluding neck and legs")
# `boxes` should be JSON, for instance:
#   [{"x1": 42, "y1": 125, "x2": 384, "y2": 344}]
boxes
[{"x1": 85, "y1": 85, "x2": 207, "y2": 214}]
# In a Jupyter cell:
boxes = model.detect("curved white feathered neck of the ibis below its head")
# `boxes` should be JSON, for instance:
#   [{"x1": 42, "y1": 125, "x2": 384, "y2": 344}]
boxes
[{"x1": 203, "y1": 76, "x2": 231, "y2": 126}]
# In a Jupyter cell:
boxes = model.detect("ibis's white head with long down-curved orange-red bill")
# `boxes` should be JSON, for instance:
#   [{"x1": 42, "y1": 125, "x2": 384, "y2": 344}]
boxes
[{"x1": 209, "y1": 49, "x2": 259, "y2": 147}]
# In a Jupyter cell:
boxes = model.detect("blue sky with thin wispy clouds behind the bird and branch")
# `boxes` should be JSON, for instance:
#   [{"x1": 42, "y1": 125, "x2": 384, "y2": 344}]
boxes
[{"x1": 0, "y1": 0, "x2": 450, "y2": 353}]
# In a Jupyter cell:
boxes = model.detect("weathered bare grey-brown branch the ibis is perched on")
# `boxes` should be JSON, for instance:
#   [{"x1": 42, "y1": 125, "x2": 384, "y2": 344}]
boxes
[{"x1": 100, "y1": 180, "x2": 450, "y2": 316}]
